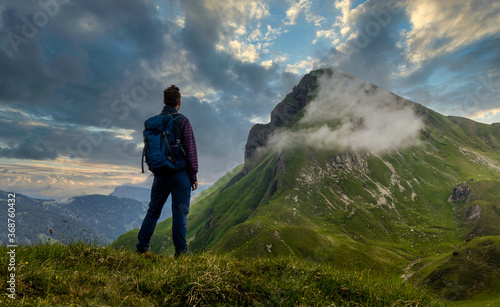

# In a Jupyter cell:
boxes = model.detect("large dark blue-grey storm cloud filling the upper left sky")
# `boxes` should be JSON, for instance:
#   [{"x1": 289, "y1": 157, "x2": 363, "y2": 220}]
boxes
[{"x1": 0, "y1": 0, "x2": 168, "y2": 118}]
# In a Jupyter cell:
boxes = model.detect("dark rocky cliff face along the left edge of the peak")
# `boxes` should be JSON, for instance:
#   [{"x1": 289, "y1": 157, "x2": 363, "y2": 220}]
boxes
[{"x1": 243, "y1": 72, "x2": 318, "y2": 174}]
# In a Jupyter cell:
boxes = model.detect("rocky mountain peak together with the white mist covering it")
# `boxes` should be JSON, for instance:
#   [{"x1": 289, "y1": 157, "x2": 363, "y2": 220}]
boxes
[{"x1": 243, "y1": 69, "x2": 429, "y2": 174}]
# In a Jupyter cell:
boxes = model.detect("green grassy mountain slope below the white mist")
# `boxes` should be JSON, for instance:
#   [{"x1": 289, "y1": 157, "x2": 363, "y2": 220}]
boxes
[{"x1": 113, "y1": 68, "x2": 500, "y2": 298}]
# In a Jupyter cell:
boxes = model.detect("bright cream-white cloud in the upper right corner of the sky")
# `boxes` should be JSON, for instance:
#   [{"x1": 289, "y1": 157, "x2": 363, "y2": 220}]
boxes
[{"x1": 401, "y1": 0, "x2": 500, "y2": 67}]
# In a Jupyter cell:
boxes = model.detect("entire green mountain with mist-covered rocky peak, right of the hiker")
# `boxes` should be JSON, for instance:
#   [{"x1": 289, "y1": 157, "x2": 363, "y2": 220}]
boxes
[{"x1": 112, "y1": 69, "x2": 500, "y2": 300}]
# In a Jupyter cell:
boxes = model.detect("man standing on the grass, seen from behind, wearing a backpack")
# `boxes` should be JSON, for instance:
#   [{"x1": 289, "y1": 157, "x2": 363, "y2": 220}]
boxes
[{"x1": 136, "y1": 85, "x2": 198, "y2": 257}]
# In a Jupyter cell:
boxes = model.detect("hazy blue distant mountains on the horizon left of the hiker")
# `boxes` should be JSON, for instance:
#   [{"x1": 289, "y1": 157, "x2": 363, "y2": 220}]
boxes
[{"x1": 0, "y1": 187, "x2": 171, "y2": 244}]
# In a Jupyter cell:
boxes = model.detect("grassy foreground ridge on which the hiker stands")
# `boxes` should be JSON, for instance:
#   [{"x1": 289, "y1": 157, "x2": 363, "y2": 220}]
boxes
[{"x1": 0, "y1": 242, "x2": 443, "y2": 307}]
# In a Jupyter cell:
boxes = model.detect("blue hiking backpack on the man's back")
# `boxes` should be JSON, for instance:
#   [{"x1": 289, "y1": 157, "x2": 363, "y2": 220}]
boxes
[{"x1": 141, "y1": 113, "x2": 186, "y2": 176}]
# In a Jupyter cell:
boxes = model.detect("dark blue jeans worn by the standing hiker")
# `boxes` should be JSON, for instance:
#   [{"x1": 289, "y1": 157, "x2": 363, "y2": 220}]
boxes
[{"x1": 136, "y1": 171, "x2": 191, "y2": 255}]
